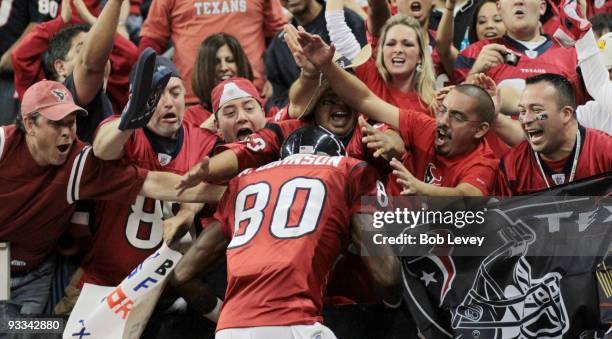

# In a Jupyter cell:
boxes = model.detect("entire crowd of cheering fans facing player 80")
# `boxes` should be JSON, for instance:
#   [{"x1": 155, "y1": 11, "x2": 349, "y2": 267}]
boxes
[{"x1": 0, "y1": 0, "x2": 612, "y2": 338}]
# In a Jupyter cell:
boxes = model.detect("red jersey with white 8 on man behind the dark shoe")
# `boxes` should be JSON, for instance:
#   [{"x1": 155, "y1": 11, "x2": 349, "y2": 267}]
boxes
[{"x1": 81, "y1": 116, "x2": 218, "y2": 286}]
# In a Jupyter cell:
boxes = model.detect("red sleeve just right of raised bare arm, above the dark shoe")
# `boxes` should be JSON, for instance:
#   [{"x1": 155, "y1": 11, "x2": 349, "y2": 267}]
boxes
[{"x1": 106, "y1": 34, "x2": 138, "y2": 112}]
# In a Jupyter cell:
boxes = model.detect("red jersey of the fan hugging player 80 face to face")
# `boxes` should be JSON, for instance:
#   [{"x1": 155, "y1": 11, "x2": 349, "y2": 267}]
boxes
[{"x1": 218, "y1": 120, "x2": 386, "y2": 170}]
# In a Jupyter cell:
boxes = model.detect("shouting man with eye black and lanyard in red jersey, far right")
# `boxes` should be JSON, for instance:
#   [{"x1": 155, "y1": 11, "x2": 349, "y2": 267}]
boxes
[{"x1": 497, "y1": 74, "x2": 612, "y2": 196}]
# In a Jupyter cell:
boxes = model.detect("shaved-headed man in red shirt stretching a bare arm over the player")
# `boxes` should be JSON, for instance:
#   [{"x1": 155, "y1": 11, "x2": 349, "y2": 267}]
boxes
[{"x1": 290, "y1": 32, "x2": 498, "y2": 196}]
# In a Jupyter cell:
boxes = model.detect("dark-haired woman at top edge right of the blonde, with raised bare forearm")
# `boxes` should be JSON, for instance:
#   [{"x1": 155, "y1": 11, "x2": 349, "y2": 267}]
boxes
[{"x1": 436, "y1": 0, "x2": 506, "y2": 74}]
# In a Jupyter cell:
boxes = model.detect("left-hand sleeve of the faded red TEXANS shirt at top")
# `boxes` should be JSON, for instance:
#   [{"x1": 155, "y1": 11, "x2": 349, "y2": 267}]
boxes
[{"x1": 138, "y1": 0, "x2": 170, "y2": 53}]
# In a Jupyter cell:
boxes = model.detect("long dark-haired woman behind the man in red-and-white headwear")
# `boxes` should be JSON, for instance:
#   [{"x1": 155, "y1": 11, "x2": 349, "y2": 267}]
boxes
[{"x1": 184, "y1": 33, "x2": 253, "y2": 126}]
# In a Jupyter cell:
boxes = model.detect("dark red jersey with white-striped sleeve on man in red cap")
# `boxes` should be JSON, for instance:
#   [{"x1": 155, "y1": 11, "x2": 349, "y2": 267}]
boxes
[{"x1": 0, "y1": 125, "x2": 148, "y2": 272}]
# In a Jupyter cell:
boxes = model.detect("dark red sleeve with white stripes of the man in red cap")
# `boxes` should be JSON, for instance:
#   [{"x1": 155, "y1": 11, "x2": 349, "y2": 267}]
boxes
[{"x1": 67, "y1": 146, "x2": 149, "y2": 204}]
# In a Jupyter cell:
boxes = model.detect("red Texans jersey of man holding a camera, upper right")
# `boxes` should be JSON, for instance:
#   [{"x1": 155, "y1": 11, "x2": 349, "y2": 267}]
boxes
[{"x1": 454, "y1": 35, "x2": 586, "y2": 105}]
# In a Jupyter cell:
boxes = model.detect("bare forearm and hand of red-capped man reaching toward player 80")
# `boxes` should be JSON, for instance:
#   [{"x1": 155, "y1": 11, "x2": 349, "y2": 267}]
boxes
[{"x1": 140, "y1": 171, "x2": 225, "y2": 204}]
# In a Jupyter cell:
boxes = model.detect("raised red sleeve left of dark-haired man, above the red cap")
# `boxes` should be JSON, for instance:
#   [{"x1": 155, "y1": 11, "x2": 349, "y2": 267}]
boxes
[{"x1": 11, "y1": 16, "x2": 64, "y2": 99}]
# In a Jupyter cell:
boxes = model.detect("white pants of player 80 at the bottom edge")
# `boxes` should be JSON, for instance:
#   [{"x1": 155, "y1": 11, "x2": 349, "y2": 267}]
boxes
[{"x1": 215, "y1": 322, "x2": 336, "y2": 339}]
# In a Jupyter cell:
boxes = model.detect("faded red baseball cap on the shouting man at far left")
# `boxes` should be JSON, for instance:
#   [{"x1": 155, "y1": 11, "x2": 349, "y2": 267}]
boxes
[{"x1": 21, "y1": 80, "x2": 87, "y2": 121}]
